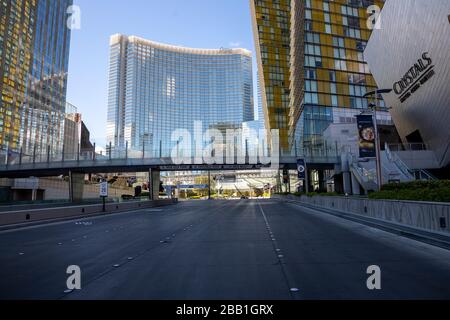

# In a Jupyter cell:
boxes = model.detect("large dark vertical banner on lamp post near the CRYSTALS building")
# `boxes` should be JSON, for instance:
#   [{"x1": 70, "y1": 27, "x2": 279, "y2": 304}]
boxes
[{"x1": 356, "y1": 115, "x2": 377, "y2": 158}]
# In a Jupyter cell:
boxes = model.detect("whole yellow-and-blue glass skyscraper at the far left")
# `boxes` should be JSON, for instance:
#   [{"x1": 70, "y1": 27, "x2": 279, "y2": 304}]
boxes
[{"x1": 0, "y1": 0, "x2": 73, "y2": 158}]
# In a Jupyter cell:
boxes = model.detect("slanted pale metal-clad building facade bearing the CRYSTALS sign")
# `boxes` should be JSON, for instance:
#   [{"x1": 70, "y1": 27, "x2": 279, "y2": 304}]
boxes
[{"x1": 365, "y1": 0, "x2": 450, "y2": 168}]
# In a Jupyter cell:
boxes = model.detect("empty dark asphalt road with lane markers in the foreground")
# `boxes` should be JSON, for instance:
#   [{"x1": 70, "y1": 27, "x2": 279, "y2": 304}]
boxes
[{"x1": 0, "y1": 200, "x2": 450, "y2": 300}]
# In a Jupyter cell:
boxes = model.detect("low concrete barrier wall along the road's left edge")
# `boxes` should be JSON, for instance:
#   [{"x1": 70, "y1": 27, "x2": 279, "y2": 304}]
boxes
[{"x1": 0, "y1": 199, "x2": 178, "y2": 226}]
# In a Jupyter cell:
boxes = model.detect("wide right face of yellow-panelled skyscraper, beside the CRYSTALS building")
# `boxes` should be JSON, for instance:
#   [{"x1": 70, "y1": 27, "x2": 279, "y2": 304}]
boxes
[{"x1": 290, "y1": 0, "x2": 384, "y2": 151}]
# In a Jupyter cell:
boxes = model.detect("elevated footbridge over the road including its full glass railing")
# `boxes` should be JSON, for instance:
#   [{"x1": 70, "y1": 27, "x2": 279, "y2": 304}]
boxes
[{"x1": 0, "y1": 143, "x2": 340, "y2": 177}]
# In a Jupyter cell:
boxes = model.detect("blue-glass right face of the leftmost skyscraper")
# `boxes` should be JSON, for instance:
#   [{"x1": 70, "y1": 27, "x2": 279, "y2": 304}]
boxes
[{"x1": 21, "y1": 0, "x2": 73, "y2": 154}]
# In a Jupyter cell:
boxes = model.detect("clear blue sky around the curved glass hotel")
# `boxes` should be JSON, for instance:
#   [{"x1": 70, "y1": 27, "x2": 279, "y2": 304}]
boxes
[{"x1": 67, "y1": 0, "x2": 256, "y2": 145}]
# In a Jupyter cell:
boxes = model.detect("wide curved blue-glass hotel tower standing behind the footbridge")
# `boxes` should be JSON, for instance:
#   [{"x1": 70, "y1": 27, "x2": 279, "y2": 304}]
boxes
[{"x1": 107, "y1": 35, "x2": 254, "y2": 157}]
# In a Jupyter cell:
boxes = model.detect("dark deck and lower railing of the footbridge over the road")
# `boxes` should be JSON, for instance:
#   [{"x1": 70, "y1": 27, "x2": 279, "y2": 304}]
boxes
[{"x1": 0, "y1": 154, "x2": 339, "y2": 178}]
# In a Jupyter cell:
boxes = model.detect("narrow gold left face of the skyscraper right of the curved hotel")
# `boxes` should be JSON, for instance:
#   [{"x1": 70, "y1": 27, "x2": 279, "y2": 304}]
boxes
[{"x1": 250, "y1": 0, "x2": 291, "y2": 151}]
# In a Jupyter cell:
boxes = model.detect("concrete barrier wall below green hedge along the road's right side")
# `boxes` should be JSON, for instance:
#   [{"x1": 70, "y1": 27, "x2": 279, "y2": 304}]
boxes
[{"x1": 275, "y1": 195, "x2": 450, "y2": 234}]
